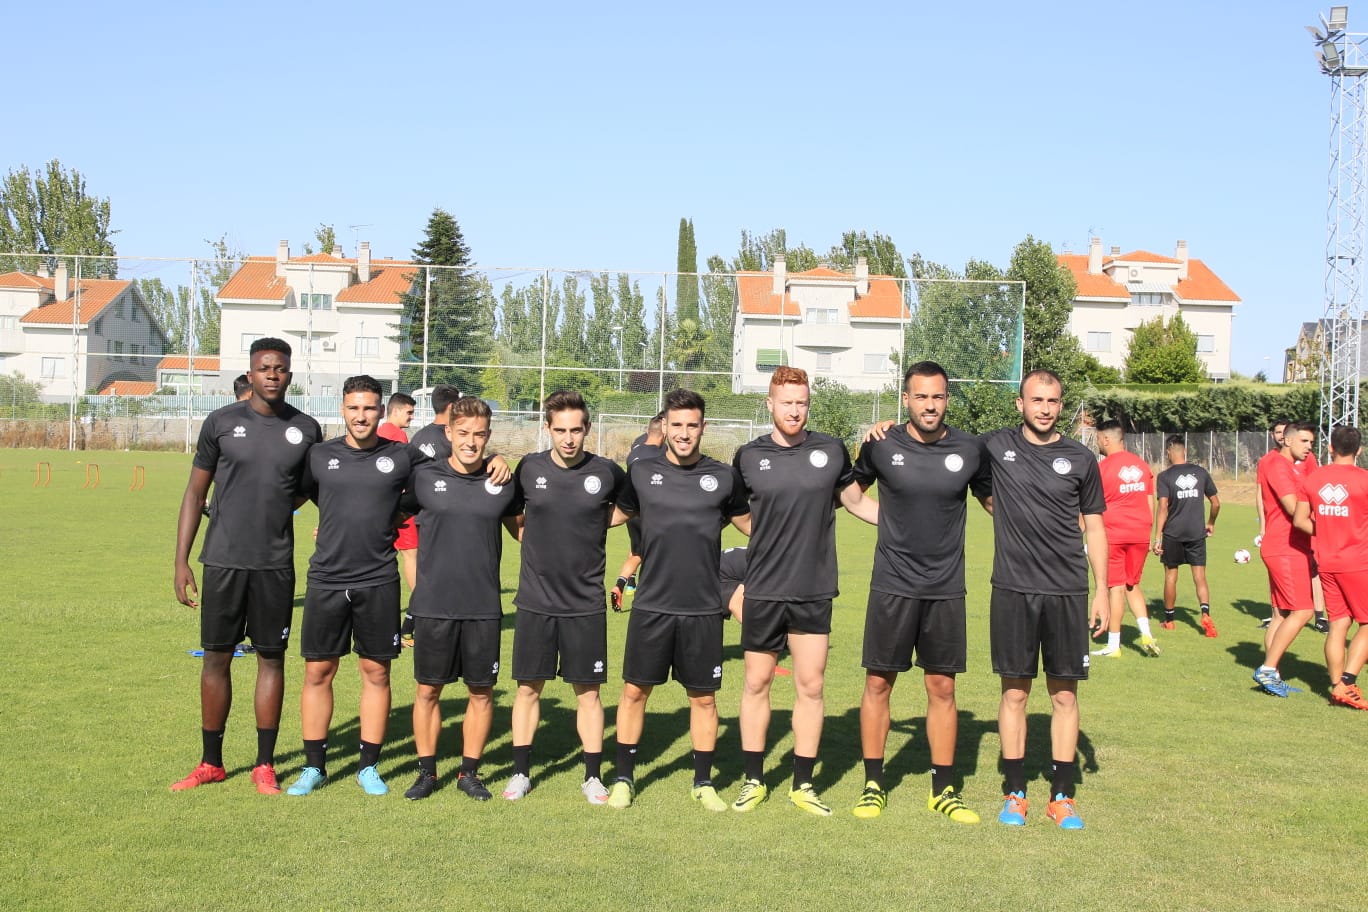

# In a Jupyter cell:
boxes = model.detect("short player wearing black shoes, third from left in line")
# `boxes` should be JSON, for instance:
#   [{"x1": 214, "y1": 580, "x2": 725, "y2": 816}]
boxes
[{"x1": 404, "y1": 397, "x2": 523, "y2": 801}]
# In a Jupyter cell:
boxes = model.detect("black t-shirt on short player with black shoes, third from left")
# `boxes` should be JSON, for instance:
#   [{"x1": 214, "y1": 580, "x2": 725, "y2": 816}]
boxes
[{"x1": 404, "y1": 459, "x2": 523, "y2": 621}]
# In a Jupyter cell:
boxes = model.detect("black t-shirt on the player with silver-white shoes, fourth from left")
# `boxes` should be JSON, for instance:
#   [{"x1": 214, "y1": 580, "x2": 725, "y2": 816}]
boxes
[{"x1": 513, "y1": 451, "x2": 627, "y2": 617}]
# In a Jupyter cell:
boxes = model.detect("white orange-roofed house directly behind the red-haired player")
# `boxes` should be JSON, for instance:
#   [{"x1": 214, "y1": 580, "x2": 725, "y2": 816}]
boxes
[{"x1": 732, "y1": 256, "x2": 910, "y2": 392}]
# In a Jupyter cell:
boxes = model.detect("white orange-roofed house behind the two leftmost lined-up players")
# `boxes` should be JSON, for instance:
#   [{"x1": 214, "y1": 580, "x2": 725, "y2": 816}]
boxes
[{"x1": 215, "y1": 241, "x2": 416, "y2": 395}]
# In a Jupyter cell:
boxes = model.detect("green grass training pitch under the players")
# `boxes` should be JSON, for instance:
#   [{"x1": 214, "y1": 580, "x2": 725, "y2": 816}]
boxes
[{"x1": 0, "y1": 450, "x2": 1368, "y2": 912}]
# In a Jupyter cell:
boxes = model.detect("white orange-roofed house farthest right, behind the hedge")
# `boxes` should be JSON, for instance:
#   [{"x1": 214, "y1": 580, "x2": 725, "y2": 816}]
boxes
[{"x1": 1059, "y1": 238, "x2": 1239, "y2": 380}]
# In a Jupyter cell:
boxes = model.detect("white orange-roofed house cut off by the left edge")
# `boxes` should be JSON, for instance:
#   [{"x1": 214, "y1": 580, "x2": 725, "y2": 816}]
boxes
[{"x1": 0, "y1": 263, "x2": 167, "y2": 399}]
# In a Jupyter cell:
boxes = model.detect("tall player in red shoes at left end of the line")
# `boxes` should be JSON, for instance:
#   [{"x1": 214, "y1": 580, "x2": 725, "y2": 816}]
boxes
[{"x1": 171, "y1": 338, "x2": 323, "y2": 794}]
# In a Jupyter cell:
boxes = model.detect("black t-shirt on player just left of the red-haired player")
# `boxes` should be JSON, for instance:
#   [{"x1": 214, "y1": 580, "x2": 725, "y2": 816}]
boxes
[{"x1": 617, "y1": 455, "x2": 750, "y2": 615}]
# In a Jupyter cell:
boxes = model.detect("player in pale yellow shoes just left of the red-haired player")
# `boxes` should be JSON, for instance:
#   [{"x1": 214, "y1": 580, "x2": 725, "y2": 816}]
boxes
[{"x1": 607, "y1": 390, "x2": 750, "y2": 811}]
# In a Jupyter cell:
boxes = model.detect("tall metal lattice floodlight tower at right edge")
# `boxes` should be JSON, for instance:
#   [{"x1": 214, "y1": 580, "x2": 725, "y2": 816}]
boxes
[{"x1": 1306, "y1": 7, "x2": 1368, "y2": 451}]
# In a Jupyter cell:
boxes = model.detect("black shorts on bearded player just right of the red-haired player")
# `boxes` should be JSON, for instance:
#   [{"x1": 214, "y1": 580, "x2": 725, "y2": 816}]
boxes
[{"x1": 863, "y1": 589, "x2": 969, "y2": 674}]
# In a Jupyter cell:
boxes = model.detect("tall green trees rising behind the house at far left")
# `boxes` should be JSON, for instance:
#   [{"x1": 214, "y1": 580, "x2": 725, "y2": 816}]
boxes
[{"x1": 0, "y1": 159, "x2": 118, "y2": 276}]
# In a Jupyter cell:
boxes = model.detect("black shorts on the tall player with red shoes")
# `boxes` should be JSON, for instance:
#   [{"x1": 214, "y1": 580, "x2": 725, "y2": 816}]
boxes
[{"x1": 200, "y1": 565, "x2": 294, "y2": 659}]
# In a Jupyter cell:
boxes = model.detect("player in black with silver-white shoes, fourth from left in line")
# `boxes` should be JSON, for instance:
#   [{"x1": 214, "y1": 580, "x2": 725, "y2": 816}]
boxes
[{"x1": 503, "y1": 390, "x2": 627, "y2": 804}]
